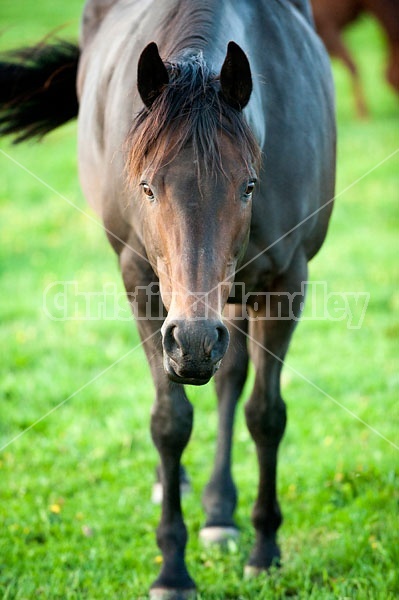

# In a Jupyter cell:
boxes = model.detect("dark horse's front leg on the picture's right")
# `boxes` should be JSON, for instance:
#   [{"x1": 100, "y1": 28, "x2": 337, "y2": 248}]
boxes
[{"x1": 245, "y1": 250, "x2": 307, "y2": 574}]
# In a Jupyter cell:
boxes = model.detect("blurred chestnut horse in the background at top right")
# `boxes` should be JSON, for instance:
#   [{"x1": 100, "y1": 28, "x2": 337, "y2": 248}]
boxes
[{"x1": 312, "y1": 0, "x2": 399, "y2": 117}]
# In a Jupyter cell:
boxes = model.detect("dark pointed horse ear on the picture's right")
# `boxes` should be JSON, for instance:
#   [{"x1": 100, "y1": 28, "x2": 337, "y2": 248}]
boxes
[{"x1": 220, "y1": 42, "x2": 252, "y2": 110}]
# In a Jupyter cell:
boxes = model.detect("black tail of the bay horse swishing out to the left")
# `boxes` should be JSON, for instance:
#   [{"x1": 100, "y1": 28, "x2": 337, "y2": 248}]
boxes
[{"x1": 0, "y1": 40, "x2": 79, "y2": 142}]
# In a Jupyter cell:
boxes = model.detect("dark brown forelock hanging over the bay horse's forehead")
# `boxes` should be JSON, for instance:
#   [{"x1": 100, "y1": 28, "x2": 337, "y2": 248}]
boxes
[{"x1": 126, "y1": 52, "x2": 261, "y2": 183}]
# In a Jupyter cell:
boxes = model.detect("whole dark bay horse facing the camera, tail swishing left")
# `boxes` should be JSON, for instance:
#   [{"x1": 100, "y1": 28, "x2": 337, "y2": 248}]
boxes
[{"x1": 0, "y1": 0, "x2": 335, "y2": 599}]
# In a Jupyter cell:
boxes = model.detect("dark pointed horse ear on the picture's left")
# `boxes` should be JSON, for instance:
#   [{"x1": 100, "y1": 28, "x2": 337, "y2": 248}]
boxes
[{"x1": 137, "y1": 42, "x2": 169, "y2": 108}]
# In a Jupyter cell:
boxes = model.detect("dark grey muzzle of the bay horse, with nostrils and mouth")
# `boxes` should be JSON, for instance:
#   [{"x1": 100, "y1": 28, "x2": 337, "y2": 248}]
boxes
[{"x1": 162, "y1": 319, "x2": 229, "y2": 385}]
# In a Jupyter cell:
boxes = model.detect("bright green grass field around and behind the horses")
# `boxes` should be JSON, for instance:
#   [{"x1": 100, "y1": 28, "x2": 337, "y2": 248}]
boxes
[{"x1": 0, "y1": 0, "x2": 399, "y2": 600}]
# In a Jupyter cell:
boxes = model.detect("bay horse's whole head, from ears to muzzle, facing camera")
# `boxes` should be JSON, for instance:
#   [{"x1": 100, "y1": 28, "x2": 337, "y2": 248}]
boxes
[{"x1": 128, "y1": 42, "x2": 260, "y2": 385}]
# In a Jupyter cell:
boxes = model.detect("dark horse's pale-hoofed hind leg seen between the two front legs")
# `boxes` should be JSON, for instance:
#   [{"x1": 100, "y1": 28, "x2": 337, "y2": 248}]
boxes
[{"x1": 200, "y1": 305, "x2": 248, "y2": 543}]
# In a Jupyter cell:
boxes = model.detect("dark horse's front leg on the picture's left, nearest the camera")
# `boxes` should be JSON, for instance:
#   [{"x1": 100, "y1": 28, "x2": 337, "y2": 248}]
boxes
[{"x1": 120, "y1": 248, "x2": 195, "y2": 600}]
